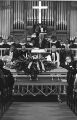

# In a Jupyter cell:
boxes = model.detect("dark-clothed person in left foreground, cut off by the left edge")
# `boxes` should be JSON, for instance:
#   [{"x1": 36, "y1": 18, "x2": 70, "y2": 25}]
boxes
[{"x1": 0, "y1": 59, "x2": 14, "y2": 110}]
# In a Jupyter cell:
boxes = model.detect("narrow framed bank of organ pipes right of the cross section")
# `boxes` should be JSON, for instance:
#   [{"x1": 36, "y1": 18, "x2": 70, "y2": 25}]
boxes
[{"x1": 56, "y1": 1, "x2": 67, "y2": 30}]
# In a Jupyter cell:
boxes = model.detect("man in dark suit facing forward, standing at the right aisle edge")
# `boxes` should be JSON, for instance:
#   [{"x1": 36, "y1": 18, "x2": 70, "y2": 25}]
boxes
[{"x1": 65, "y1": 56, "x2": 76, "y2": 108}]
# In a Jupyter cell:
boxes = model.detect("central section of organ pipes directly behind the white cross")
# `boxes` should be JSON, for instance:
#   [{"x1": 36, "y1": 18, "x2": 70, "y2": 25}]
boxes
[{"x1": 26, "y1": 1, "x2": 54, "y2": 26}]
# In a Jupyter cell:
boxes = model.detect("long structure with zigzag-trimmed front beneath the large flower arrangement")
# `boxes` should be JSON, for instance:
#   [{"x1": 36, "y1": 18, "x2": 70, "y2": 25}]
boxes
[{"x1": 5, "y1": 67, "x2": 67, "y2": 96}]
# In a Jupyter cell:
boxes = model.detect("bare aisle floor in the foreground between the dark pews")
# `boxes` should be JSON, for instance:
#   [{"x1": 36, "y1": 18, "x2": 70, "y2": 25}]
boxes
[{"x1": 1, "y1": 102, "x2": 77, "y2": 120}]
